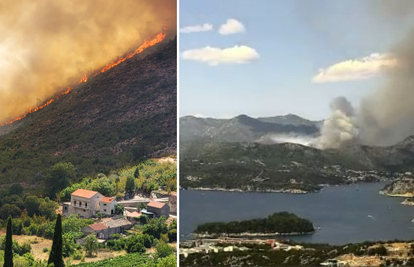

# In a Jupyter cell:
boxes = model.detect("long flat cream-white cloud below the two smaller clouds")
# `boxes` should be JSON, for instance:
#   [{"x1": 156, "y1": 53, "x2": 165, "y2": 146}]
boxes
[{"x1": 182, "y1": 45, "x2": 260, "y2": 66}]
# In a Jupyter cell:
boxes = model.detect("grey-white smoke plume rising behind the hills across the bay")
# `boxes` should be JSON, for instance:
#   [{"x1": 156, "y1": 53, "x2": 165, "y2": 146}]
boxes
[{"x1": 319, "y1": 0, "x2": 414, "y2": 148}]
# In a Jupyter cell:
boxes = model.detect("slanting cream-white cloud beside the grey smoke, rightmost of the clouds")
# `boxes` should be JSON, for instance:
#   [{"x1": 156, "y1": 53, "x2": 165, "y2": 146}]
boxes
[{"x1": 312, "y1": 54, "x2": 397, "y2": 83}]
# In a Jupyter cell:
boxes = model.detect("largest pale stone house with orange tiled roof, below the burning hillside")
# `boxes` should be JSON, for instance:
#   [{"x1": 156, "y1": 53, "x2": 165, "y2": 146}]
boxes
[{"x1": 66, "y1": 189, "x2": 104, "y2": 218}]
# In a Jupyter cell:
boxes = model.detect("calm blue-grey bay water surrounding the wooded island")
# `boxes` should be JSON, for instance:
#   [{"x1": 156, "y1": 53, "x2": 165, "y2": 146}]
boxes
[{"x1": 179, "y1": 183, "x2": 414, "y2": 244}]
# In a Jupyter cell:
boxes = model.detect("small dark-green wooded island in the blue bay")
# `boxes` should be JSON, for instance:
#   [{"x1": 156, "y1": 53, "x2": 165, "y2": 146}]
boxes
[{"x1": 195, "y1": 212, "x2": 315, "y2": 237}]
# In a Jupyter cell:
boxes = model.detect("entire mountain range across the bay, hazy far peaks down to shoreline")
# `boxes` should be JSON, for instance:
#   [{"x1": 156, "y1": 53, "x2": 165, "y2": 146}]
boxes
[{"x1": 180, "y1": 114, "x2": 414, "y2": 191}]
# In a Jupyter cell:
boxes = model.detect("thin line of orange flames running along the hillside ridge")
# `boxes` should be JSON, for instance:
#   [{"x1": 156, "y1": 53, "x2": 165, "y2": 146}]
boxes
[{"x1": 0, "y1": 31, "x2": 167, "y2": 126}]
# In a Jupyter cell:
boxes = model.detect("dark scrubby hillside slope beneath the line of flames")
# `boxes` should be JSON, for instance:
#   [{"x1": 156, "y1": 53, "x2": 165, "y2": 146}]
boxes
[{"x1": 0, "y1": 36, "x2": 177, "y2": 188}]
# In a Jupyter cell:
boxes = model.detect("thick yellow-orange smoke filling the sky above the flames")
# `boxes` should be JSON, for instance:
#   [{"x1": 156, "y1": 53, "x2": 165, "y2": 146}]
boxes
[{"x1": 0, "y1": 0, "x2": 177, "y2": 123}]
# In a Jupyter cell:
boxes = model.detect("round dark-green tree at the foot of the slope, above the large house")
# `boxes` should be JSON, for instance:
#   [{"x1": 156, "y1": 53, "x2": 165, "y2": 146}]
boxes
[{"x1": 45, "y1": 162, "x2": 76, "y2": 198}]
